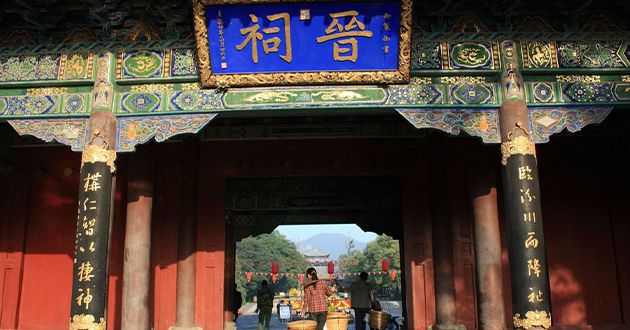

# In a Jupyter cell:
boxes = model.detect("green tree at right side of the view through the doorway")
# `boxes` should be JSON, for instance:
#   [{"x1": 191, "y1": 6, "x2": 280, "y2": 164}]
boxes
[{"x1": 339, "y1": 235, "x2": 400, "y2": 288}]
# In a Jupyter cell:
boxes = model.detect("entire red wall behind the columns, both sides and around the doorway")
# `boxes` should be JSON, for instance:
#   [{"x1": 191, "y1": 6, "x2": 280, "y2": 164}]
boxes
[{"x1": 0, "y1": 138, "x2": 630, "y2": 330}]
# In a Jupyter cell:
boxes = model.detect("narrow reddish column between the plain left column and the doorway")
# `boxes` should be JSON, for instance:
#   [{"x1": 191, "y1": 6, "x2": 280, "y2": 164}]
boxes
[{"x1": 170, "y1": 147, "x2": 201, "y2": 330}]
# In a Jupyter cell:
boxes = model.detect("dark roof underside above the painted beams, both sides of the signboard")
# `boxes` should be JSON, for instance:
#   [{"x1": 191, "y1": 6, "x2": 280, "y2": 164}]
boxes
[{"x1": 0, "y1": 0, "x2": 630, "y2": 46}]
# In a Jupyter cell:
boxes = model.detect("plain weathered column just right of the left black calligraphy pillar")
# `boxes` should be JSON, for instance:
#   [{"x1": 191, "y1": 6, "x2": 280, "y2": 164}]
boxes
[{"x1": 121, "y1": 153, "x2": 153, "y2": 330}]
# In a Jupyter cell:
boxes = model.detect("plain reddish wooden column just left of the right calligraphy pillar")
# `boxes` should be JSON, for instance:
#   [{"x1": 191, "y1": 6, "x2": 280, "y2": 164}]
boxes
[{"x1": 468, "y1": 148, "x2": 506, "y2": 330}]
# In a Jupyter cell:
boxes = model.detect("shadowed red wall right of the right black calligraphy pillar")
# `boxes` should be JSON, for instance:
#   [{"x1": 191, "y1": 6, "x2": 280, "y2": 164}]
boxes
[{"x1": 539, "y1": 137, "x2": 630, "y2": 328}]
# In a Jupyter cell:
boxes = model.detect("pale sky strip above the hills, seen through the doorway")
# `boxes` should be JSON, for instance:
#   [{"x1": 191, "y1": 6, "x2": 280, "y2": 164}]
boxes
[{"x1": 277, "y1": 224, "x2": 377, "y2": 243}]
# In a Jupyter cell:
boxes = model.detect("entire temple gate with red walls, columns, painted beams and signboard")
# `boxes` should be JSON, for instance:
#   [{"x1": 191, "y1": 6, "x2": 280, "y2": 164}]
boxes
[{"x1": 0, "y1": 0, "x2": 630, "y2": 330}]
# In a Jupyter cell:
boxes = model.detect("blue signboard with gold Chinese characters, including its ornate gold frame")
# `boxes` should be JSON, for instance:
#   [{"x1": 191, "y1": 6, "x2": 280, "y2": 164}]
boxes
[{"x1": 195, "y1": 0, "x2": 411, "y2": 87}]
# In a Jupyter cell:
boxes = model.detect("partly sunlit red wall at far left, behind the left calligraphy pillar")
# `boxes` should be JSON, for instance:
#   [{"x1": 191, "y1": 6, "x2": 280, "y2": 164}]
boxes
[{"x1": 0, "y1": 148, "x2": 124, "y2": 330}]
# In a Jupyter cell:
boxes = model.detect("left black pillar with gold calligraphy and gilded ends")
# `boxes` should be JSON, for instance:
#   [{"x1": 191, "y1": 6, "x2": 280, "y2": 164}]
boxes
[{"x1": 70, "y1": 112, "x2": 116, "y2": 330}]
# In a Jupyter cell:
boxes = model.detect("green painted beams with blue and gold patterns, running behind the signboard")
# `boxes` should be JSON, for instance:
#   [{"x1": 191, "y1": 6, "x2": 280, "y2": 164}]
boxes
[{"x1": 0, "y1": 38, "x2": 630, "y2": 119}]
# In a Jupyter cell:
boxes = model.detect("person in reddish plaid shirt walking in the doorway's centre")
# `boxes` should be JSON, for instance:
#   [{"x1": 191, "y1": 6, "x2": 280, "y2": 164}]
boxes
[{"x1": 304, "y1": 267, "x2": 333, "y2": 330}]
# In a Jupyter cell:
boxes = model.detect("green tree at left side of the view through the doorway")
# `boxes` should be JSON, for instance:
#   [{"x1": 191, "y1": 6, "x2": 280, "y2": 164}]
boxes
[{"x1": 236, "y1": 231, "x2": 308, "y2": 301}]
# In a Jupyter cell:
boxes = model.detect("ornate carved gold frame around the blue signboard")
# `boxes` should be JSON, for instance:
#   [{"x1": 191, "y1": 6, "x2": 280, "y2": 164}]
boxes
[{"x1": 192, "y1": 0, "x2": 412, "y2": 88}]
